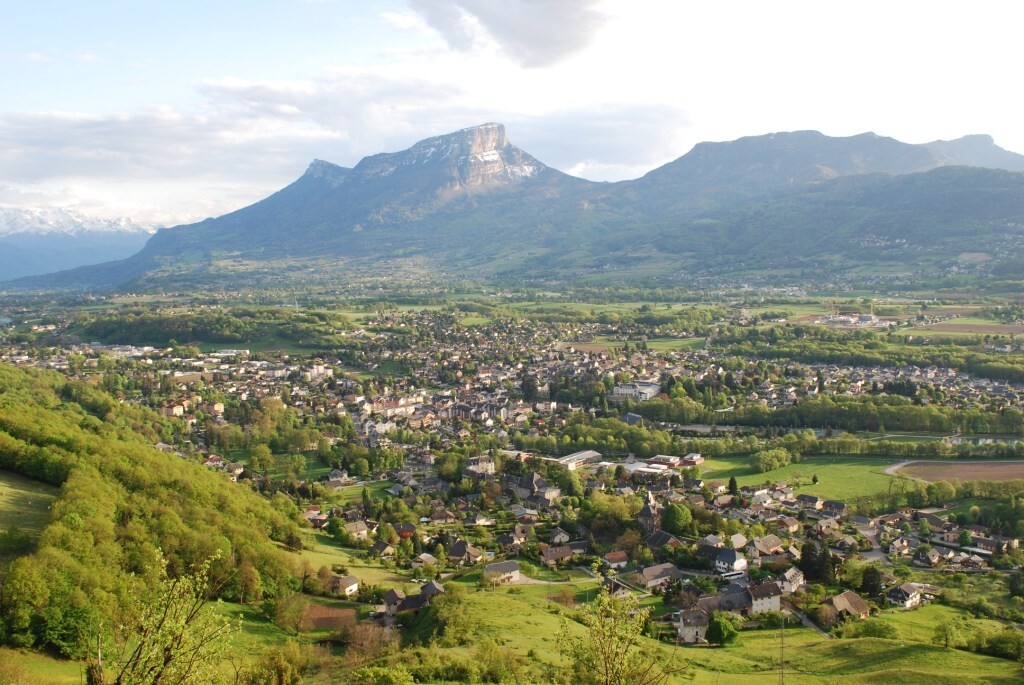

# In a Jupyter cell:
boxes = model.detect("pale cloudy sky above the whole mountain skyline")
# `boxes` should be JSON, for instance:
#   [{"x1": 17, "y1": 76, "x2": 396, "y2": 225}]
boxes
[{"x1": 0, "y1": 0, "x2": 1024, "y2": 225}]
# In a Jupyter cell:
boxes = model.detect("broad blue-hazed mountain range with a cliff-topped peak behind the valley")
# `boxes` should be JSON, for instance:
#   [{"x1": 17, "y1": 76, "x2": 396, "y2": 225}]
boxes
[{"x1": 10, "y1": 123, "x2": 1024, "y2": 289}]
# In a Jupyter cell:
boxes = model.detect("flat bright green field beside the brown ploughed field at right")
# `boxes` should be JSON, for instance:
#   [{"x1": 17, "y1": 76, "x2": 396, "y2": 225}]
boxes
[{"x1": 700, "y1": 457, "x2": 901, "y2": 501}]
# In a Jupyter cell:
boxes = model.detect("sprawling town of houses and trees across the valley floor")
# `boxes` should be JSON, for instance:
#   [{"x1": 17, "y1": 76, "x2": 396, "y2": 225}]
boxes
[{"x1": 3, "y1": 305, "x2": 1024, "y2": 644}]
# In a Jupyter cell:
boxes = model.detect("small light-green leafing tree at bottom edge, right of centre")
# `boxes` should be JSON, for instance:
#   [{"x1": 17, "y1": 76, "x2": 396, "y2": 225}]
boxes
[{"x1": 558, "y1": 592, "x2": 682, "y2": 685}]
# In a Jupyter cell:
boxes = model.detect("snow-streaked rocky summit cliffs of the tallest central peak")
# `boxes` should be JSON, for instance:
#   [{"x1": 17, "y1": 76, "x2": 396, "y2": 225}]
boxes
[{"x1": 352, "y1": 124, "x2": 547, "y2": 190}]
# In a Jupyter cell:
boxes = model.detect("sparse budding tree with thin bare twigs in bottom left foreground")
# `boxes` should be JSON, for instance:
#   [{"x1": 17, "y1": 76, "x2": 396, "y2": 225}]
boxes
[{"x1": 101, "y1": 550, "x2": 239, "y2": 685}]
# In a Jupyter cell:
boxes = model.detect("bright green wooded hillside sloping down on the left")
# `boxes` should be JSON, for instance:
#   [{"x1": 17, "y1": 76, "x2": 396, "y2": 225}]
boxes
[{"x1": 0, "y1": 365, "x2": 300, "y2": 657}]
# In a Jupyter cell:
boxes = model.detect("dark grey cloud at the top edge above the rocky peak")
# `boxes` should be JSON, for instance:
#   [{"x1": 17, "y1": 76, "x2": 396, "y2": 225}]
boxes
[{"x1": 409, "y1": 0, "x2": 607, "y2": 68}]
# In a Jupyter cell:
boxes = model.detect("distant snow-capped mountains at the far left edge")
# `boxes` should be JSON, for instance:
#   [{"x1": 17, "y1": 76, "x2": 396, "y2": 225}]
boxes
[{"x1": 0, "y1": 208, "x2": 154, "y2": 282}]
